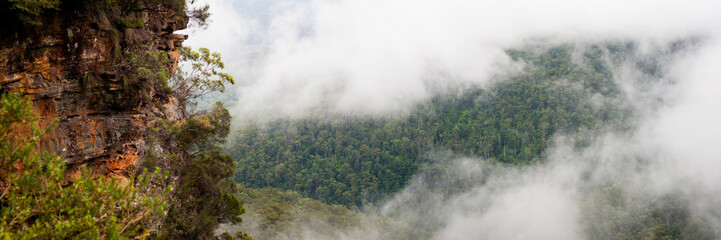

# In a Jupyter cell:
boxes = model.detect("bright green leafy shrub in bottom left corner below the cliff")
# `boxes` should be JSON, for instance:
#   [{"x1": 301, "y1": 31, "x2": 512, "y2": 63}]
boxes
[{"x1": 0, "y1": 90, "x2": 171, "y2": 239}]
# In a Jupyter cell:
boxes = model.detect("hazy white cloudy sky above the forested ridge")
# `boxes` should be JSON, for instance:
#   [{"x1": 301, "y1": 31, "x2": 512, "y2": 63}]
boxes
[{"x1": 187, "y1": 0, "x2": 721, "y2": 119}]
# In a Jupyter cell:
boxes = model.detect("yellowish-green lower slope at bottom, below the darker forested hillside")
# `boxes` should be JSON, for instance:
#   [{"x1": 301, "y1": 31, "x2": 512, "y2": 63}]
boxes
[{"x1": 226, "y1": 184, "x2": 422, "y2": 239}]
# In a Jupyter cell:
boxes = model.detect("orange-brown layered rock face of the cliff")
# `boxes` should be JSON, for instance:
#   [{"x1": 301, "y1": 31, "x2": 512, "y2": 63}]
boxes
[{"x1": 0, "y1": 7, "x2": 187, "y2": 181}]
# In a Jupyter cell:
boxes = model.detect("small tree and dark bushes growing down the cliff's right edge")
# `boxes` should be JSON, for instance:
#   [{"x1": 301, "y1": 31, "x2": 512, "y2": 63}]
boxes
[{"x1": 140, "y1": 48, "x2": 244, "y2": 239}]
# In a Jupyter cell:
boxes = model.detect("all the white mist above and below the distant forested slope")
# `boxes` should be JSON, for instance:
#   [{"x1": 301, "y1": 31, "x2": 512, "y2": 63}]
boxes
[{"x1": 187, "y1": 0, "x2": 721, "y2": 239}]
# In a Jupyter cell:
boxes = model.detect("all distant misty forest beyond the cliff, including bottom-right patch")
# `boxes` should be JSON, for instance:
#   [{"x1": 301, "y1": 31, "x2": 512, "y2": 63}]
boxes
[{"x1": 225, "y1": 40, "x2": 712, "y2": 239}]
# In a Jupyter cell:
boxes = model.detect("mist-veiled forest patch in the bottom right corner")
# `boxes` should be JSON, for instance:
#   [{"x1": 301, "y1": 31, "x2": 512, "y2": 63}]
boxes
[{"x1": 581, "y1": 182, "x2": 716, "y2": 240}]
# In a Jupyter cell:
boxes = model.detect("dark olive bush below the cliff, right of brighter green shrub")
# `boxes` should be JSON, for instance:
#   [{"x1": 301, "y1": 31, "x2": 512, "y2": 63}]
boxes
[{"x1": 159, "y1": 103, "x2": 244, "y2": 239}]
